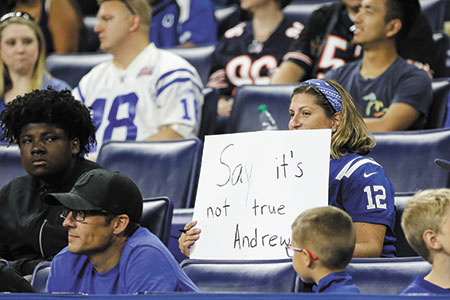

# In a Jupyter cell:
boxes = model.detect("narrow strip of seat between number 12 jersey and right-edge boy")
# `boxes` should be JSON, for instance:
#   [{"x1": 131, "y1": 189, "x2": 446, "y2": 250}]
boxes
[{"x1": 394, "y1": 193, "x2": 419, "y2": 257}]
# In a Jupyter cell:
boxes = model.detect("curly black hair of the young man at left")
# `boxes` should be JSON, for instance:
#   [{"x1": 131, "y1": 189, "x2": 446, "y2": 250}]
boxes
[{"x1": 0, "y1": 88, "x2": 97, "y2": 155}]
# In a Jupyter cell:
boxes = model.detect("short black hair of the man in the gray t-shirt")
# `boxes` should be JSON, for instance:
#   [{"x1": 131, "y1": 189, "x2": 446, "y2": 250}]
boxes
[{"x1": 386, "y1": 0, "x2": 421, "y2": 38}]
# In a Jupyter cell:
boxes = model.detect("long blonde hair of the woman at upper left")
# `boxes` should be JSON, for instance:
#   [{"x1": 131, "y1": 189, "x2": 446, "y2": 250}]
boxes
[{"x1": 0, "y1": 17, "x2": 46, "y2": 96}]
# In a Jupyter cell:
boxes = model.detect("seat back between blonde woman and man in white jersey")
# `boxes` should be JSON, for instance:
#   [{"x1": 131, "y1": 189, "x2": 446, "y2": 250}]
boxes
[{"x1": 46, "y1": 53, "x2": 112, "y2": 88}]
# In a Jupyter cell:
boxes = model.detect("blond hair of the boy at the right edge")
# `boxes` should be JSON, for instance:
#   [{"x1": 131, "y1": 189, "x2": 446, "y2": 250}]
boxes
[{"x1": 401, "y1": 188, "x2": 450, "y2": 263}]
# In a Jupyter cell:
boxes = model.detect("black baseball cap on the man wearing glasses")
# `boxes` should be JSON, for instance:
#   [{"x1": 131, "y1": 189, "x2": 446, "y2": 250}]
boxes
[{"x1": 44, "y1": 169, "x2": 143, "y2": 223}]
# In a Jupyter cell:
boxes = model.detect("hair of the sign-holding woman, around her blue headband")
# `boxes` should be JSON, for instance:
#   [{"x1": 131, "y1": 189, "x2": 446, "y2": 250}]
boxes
[{"x1": 291, "y1": 79, "x2": 375, "y2": 159}]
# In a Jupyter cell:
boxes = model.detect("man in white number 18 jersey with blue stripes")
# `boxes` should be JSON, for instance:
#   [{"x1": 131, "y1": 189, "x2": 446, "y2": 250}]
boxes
[{"x1": 73, "y1": 0, "x2": 203, "y2": 156}]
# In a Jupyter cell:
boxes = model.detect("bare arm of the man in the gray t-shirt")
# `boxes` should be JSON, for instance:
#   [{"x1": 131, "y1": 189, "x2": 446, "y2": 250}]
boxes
[{"x1": 364, "y1": 102, "x2": 420, "y2": 131}]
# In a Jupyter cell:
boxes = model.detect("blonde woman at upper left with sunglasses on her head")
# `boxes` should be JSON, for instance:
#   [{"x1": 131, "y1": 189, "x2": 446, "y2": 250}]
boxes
[{"x1": 0, "y1": 12, "x2": 70, "y2": 135}]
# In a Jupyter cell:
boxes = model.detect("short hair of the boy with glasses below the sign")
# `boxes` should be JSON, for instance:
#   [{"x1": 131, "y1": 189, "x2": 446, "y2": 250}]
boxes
[{"x1": 292, "y1": 206, "x2": 356, "y2": 270}]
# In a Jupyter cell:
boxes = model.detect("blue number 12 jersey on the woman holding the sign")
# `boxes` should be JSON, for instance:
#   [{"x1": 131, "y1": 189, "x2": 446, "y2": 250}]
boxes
[{"x1": 328, "y1": 153, "x2": 396, "y2": 257}]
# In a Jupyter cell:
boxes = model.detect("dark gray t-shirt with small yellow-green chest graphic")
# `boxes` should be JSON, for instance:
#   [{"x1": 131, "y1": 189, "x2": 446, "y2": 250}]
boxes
[{"x1": 325, "y1": 56, "x2": 433, "y2": 129}]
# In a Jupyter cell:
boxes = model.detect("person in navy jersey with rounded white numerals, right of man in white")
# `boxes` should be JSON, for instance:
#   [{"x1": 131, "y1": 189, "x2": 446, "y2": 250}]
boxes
[{"x1": 208, "y1": 0, "x2": 302, "y2": 116}]
